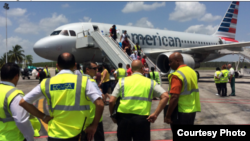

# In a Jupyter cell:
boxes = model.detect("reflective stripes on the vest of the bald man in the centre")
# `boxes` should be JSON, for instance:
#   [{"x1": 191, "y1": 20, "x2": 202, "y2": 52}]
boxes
[{"x1": 121, "y1": 78, "x2": 154, "y2": 102}]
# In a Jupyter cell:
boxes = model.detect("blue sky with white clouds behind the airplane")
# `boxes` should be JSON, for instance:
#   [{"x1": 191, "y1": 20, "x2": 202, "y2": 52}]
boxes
[{"x1": 0, "y1": 0, "x2": 250, "y2": 62}]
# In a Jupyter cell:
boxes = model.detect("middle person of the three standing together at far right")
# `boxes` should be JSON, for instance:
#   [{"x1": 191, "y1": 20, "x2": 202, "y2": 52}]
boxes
[{"x1": 220, "y1": 65, "x2": 228, "y2": 96}]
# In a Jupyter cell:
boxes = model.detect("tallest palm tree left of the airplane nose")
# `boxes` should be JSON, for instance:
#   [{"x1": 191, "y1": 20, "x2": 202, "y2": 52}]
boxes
[{"x1": 8, "y1": 45, "x2": 25, "y2": 63}]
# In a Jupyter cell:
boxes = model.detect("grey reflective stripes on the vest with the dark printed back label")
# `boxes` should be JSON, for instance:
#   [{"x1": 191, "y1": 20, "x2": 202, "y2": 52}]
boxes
[{"x1": 45, "y1": 76, "x2": 90, "y2": 112}]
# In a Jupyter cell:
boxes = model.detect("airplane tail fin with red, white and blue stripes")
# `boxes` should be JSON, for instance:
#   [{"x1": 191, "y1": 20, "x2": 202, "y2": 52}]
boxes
[{"x1": 213, "y1": 1, "x2": 239, "y2": 42}]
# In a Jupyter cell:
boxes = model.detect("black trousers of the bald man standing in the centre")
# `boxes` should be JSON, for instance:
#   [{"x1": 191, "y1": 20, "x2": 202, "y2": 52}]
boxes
[{"x1": 117, "y1": 113, "x2": 150, "y2": 141}]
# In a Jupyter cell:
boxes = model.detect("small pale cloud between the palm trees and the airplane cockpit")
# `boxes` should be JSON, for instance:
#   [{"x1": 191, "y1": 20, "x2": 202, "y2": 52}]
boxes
[{"x1": 15, "y1": 22, "x2": 39, "y2": 34}]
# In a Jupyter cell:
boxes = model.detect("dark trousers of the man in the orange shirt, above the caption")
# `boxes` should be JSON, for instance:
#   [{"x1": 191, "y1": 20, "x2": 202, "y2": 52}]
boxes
[{"x1": 170, "y1": 112, "x2": 196, "y2": 133}]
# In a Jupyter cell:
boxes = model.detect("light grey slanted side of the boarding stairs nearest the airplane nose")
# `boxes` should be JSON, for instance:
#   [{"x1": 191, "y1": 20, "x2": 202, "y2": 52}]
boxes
[{"x1": 90, "y1": 31, "x2": 132, "y2": 69}]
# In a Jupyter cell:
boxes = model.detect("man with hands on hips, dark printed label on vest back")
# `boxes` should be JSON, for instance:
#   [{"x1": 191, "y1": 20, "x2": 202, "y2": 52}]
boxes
[{"x1": 19, "y1": 53, "x2": 104, "y2": 141}]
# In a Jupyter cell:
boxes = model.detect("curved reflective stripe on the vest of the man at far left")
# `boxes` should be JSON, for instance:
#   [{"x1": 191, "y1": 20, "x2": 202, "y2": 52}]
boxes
[{"x1": 0, "y1": 88, "x2": 17, "y2": 123}]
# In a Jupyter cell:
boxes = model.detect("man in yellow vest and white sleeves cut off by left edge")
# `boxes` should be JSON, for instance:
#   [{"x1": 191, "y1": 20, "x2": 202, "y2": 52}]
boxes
[{"x1": 0, "y1": 63, "x2": 34, "y2": 141}]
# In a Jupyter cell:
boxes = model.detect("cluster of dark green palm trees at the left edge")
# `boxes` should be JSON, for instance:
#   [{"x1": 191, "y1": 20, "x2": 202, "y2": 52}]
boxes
[{"x1": 0, "y1": 45, "x2": 33, "y2": 68}]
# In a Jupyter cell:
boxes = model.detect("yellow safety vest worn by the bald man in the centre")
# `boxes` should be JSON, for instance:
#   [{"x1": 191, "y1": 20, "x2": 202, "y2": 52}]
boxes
[{"x1": 117, "y1": 74, "x2": 156, "y2": 116}]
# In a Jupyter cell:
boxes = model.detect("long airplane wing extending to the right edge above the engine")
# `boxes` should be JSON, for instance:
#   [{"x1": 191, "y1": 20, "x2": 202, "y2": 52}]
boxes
[{"x1": 145, "y1": 42, "x2": 250, "y2": 54}]
